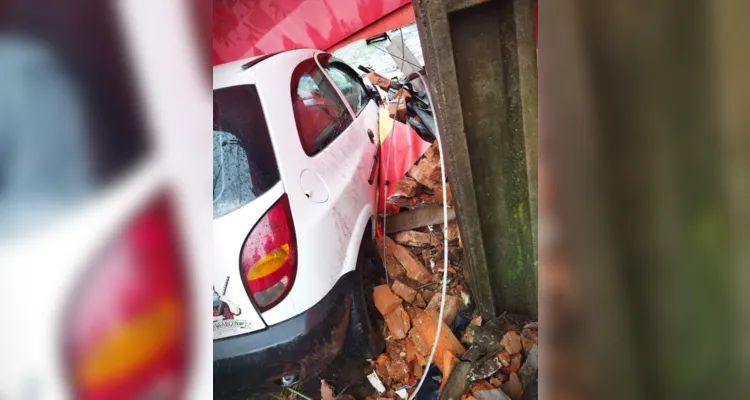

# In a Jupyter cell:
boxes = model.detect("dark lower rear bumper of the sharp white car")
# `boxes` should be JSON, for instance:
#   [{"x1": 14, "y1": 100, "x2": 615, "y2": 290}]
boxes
[{"x1": 213, "y1": 272, "x2": 358, "y2": 397}]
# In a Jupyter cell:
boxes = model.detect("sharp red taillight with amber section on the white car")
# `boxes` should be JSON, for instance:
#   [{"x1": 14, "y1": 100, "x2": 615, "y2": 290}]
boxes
[{"x1": 240, "y1": 194, "x2": 297, "y2": 312}]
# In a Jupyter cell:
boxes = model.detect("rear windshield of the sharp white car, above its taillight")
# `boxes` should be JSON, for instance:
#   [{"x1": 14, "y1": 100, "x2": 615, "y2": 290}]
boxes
[{"x1": 214, "y1": 85, "x2": 279, "y2": 218}]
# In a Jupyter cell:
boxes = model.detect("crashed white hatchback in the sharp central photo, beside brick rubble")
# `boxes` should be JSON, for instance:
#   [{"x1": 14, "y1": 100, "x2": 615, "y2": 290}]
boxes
[{"x1": 213, "y1": 49, "x2": 379, "y2": 397}]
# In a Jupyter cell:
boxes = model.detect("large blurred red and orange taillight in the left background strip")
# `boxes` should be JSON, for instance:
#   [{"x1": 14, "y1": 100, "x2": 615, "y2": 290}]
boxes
[{"x1": 63, "y1": 198, "x2": 191, "y2": 399}]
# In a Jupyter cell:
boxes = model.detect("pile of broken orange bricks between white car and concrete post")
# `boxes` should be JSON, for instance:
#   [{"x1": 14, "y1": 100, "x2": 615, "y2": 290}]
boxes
[{"x1": 366, "y1": 144, "x2": 538, "y2": 400}]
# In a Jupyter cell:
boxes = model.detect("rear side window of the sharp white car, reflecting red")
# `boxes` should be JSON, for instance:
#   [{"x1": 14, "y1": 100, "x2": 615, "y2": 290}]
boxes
[{"x1": 292, "y1": 59, "x2": 352, "y2": 156}]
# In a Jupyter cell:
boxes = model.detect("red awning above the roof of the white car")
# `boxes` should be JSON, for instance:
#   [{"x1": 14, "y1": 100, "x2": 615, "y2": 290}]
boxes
[{"x1": 213, "y1": 0, "x2": 414, "y2": 65}]
